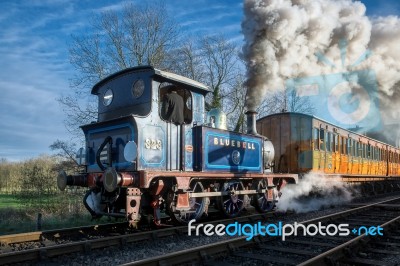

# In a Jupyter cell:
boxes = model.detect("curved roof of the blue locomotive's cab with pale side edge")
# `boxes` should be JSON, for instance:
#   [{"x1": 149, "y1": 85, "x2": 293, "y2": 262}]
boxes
[{"x1": 92, "y1": 66, "x2": 211, "y2": 95}]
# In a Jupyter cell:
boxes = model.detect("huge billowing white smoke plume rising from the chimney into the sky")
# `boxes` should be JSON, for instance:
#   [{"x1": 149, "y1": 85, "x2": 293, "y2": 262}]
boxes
[{"x1": 242, "y1": 0, "x2": 400, "y2": 144}]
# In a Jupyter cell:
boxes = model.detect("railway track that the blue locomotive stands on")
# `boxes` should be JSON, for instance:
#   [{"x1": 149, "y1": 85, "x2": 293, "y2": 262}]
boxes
[{"x1": 0, "y1": 212, "x2": 274, "y2": 265}]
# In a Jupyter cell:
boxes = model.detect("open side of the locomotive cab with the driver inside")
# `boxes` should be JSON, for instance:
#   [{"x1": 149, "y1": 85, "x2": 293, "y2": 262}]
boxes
[{"x1": 159, "y1": 82, "x2": 193, "y2": 124}]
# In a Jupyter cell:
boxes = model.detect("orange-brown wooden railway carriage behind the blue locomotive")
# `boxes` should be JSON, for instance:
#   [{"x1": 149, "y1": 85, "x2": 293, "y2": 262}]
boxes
[{"x1": 257, "y1": 112, "x2": 400, "y2": 188}]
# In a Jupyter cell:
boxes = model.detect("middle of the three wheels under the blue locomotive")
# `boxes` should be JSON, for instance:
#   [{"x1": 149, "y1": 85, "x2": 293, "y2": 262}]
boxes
[{"x1": 220, "y1": 181, "x2": 245, "y2": 217}]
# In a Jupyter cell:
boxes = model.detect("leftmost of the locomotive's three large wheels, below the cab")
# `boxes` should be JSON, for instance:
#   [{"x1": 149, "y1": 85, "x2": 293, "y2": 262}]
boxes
[{"x1": 167, "y1": 181, "x2": 208, "y2": 224}]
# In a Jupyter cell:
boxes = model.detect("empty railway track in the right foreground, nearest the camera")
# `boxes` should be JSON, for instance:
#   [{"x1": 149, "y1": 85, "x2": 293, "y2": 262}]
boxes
[{"x1": 121, "y1": 197, "x2": 400, "y2": 266}]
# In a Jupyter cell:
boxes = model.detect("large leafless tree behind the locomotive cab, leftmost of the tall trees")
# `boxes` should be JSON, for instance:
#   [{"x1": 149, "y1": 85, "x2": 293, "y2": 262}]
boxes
[{"x1": 59, "y1": 1, "x2": 180, "y2": 136}]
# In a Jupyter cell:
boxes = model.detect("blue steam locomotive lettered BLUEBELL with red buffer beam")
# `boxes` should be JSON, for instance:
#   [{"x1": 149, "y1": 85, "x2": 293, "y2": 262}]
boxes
[{"x1": 57, "y1": 66, "x2": 297, "y2": 226}]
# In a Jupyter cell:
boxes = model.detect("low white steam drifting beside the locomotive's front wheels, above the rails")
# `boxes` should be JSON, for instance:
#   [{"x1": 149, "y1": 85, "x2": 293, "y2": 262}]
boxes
[{"x1": 276, "y1": 173, "x2": 356, "y2": 213}]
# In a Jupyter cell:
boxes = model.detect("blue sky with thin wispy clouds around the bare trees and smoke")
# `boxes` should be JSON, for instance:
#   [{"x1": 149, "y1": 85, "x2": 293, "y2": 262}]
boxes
[{"x1": 0, "y1": 0, "x2": 400, "y2": 161}]
